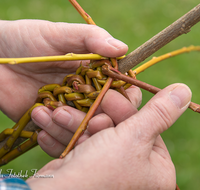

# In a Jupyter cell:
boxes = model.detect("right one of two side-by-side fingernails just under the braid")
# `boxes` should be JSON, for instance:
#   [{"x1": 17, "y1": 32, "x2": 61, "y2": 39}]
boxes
[{"x1": 53, "y1": 109, "x2": 72, "y2": 127}]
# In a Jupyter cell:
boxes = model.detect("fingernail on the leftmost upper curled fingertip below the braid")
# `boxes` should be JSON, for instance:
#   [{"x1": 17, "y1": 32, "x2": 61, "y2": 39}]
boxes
[{"x1": 32, "y1": 109, "x2": 52, "y2": 129}]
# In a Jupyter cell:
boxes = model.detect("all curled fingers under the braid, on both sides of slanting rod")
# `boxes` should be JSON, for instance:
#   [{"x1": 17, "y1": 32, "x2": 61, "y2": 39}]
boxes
[{"x1": 31, "y1": 86, "x2": 142, "y2": 158}]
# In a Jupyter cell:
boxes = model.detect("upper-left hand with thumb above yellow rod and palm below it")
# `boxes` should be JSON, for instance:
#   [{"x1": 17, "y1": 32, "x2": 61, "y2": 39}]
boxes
[{"x1": 0, "y1": 20, "x2": 128, "y2": 121}]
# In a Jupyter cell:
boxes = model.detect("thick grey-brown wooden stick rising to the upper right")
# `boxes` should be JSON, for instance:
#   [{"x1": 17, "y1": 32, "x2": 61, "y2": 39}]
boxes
[{"x1": 119, "y1": 4, "x2": 200, "y2": 73}]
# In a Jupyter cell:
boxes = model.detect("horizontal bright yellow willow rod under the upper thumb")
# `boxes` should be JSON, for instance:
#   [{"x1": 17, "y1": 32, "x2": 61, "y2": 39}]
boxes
[{"x1": 0, "y1": 53, "x2": 125, "y2": 65}]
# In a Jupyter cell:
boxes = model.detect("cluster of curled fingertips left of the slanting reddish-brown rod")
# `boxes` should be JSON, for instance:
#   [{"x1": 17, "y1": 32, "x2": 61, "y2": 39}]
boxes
[{"x1": 32, "y1": 106, "x2": 85, "y2": 157}]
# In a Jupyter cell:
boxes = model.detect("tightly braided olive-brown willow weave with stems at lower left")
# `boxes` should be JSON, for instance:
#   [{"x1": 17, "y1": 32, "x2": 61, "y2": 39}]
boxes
[{"x1": 0, "y1": 60, "x2": 133, "y2": 165}]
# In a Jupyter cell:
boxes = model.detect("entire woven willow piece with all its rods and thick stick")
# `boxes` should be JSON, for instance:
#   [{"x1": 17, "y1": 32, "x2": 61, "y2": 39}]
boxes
[{"x1": 0, "y1": 0, "x2": 200, "y2": 190}]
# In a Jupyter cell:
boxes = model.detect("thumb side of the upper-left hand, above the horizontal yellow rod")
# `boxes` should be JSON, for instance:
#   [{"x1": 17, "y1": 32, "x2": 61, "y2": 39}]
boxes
[{"x1": 0, "y1": 20, "x2": 128, "y2": 57}]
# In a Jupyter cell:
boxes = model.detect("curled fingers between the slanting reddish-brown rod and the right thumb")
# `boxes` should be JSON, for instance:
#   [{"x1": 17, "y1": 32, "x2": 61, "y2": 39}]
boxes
[{"x1": 87, "y1": 87, "x2": 142, "y2": 138}]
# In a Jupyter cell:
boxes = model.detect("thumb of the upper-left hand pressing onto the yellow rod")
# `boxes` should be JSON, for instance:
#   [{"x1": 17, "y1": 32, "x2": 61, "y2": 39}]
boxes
[{"x1": 40, "y1": 22, "x2": 128, "y2": 57}]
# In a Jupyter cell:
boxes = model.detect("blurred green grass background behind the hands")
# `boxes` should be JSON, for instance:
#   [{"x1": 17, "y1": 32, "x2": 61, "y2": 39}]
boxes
[{"x1": 0, "y1": 0, "x2": 200, "y2": 189}]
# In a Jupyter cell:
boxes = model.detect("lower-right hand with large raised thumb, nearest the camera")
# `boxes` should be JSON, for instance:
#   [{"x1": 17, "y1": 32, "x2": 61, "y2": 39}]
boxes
[{"x1": 27, "y1": 84, "x2": 191, "y2": 190}]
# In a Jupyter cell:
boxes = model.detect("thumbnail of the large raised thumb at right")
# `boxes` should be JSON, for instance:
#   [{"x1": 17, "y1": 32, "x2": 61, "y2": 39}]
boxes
[{"x1": 170, "y1": 84, "x2": 192, "y2": 109}]
